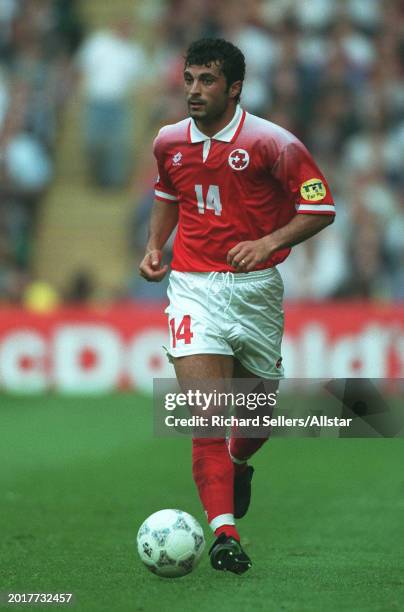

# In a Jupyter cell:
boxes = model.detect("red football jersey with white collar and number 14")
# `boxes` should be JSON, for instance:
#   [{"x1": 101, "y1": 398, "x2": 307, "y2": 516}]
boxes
[{"x1": 154, "y1": 106, "x2": 335, "y2": 272}]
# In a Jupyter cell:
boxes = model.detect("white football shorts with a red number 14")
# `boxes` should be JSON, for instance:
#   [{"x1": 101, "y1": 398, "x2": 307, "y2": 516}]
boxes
[{"x1": 165, "y1": 268, "x2": 284, "y2": 379}]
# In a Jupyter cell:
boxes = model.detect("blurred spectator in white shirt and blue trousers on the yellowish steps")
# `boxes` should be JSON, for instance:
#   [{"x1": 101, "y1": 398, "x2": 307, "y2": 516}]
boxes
[{"x1": 77, "y1": 22, "x2": 144, "y2": 187}]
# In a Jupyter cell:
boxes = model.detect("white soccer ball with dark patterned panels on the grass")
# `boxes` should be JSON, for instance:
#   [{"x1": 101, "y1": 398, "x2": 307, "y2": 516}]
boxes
[{"x1": 137, "y1": 510, "x2": 205, "y2": 578}]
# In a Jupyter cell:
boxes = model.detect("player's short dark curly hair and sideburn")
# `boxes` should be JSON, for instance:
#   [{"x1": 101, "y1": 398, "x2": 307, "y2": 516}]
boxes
[{"x1": 185, "y1": 38, "x2": 245, "y2": 102}]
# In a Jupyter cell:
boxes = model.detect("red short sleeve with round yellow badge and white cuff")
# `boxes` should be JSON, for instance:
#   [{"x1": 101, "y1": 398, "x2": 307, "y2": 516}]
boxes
[{"x1": 272, "y1": 139, "x2": 335, "y2": 215}]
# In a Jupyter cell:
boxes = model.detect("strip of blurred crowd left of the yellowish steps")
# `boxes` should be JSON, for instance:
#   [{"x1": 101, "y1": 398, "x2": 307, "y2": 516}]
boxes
[{"x1": 0, "y1": 0, "x2": 82, "y2": 303}]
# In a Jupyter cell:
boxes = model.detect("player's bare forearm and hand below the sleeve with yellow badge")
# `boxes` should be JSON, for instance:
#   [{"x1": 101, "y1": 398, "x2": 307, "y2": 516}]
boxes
[{"x1": 227, "y1": 214, "x2": 335, "y2": 272}]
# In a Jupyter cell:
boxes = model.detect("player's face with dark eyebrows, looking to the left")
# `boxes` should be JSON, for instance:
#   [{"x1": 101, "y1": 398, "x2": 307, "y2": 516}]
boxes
[{"x1": 184, "y1": 62, "x2": 237, "y2": 122}]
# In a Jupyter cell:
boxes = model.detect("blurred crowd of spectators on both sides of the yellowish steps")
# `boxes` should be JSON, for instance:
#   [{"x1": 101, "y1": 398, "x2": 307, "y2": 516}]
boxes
[{"x1": 0, "y1": 0, "x2": 404, "y2": 300}]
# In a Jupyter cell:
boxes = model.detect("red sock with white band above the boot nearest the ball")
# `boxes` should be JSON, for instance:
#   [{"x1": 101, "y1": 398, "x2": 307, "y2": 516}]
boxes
[{"x1": 192, "y1": 438, "x2": 238, "y2": 538}]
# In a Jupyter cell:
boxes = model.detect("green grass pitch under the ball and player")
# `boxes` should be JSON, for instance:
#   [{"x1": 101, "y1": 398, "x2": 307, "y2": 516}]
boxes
[{"x1": 0, "y1": 394, "x2": 404, "y2": 612}]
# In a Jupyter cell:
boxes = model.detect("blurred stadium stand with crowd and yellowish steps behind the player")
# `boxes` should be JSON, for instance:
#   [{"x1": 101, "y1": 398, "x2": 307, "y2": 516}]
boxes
[{"x1": 0, "y1": 0, "x2": 404, "y2": 303}]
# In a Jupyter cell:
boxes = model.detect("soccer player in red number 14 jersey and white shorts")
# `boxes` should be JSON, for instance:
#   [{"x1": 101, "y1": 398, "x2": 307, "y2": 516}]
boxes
[{"x1": 140, "y1": 39, "x2": 334, "y2": 574}]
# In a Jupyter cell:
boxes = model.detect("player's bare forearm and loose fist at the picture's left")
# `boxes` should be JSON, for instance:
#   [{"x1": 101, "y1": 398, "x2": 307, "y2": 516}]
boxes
[{"x1": 139, "y1": 200, "x2": 178, "y2": 282}]
